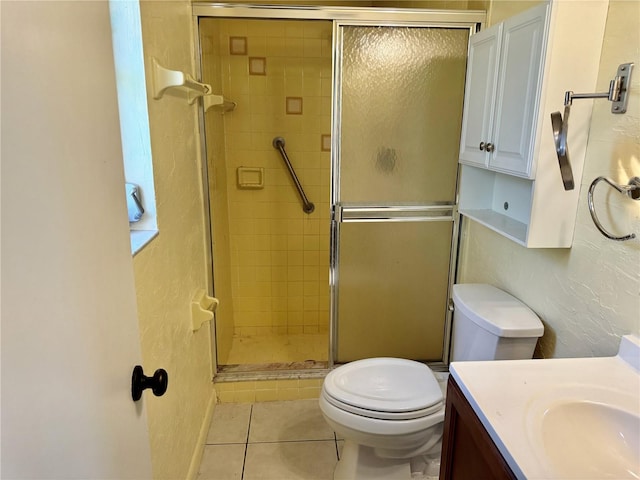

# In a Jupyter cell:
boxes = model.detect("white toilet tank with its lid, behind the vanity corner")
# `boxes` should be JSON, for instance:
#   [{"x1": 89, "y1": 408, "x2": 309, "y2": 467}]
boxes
[{"x1": 450, "y1": 283, "x2": 544, "y2": 362}]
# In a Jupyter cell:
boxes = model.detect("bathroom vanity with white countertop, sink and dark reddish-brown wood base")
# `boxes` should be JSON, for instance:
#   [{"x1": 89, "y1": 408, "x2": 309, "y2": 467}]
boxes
[{"x1": 440, "y1": 335, "x2": 640, "y2": 480}]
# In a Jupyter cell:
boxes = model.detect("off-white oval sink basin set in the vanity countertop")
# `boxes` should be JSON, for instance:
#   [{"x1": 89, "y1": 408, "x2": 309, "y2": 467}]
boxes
[{"x1": 541, "y1": 401, "x2": 640, "y2": 479}]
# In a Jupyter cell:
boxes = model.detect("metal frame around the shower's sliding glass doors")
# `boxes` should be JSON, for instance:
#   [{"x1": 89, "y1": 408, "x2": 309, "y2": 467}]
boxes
[{"x1": 191, "y1": 2, "x2": 486, "y2": 376}]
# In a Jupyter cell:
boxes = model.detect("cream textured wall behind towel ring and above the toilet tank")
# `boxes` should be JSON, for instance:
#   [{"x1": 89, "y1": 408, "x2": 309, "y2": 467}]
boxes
[{"x1": 460, "y1": 0, "x2": 640, "y2": 357}]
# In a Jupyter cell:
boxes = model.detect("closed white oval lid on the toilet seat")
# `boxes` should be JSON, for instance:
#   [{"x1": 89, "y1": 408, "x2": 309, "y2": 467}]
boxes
[{"x1": 324, "y1": 358, "x2": 443, "y2": 413}]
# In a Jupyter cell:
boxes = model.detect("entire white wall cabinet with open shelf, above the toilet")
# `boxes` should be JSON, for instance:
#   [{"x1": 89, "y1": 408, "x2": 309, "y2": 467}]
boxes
[{"x1": 460, "y1": 0, "x2": 614, "y2": 248}]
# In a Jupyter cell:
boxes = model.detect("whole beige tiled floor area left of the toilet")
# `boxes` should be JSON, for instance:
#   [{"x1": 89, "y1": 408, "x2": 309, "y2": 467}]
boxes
[{"x1": 198, "y1": 399, "x2": 342, "y2": 480}]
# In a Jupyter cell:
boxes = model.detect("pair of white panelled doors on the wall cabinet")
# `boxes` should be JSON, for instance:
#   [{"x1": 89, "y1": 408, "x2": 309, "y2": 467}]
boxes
[{"x1": 460, "y1": 5, "x2": 549, "y2": 177}]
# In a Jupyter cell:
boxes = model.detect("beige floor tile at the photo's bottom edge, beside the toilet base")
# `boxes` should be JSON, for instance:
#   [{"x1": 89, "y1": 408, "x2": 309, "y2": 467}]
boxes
[{"x1": 244, "y1": 441, "x2": 338, "y2": 480}]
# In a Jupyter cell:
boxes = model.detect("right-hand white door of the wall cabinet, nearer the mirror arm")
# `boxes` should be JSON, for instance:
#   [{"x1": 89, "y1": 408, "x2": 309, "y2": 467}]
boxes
[{"x1": 489, "y1": 5, "x2": 547, "y2": 177}]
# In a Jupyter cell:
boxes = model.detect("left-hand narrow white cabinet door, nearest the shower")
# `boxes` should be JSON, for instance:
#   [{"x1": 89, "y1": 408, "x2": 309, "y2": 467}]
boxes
[{"x1": 460, "y1": 24, "x2": 502, "y2": 167}]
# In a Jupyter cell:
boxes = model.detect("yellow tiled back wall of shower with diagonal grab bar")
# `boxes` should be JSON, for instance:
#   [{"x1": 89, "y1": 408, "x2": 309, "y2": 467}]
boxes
[{"x1": 201, "y1": 19, "x2": 332, "y2": 348}]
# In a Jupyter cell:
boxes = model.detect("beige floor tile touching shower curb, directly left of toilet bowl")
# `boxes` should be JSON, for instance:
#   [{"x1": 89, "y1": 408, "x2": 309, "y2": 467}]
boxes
[{"x1": 249, "y1": 399, "x2": 334, "y2": 443}]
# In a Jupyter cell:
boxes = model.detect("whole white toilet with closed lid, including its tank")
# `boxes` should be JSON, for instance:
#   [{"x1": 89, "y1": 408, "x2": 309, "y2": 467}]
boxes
[{"x1": 319, "y1": 284, "x2": 544, "y2": 480}]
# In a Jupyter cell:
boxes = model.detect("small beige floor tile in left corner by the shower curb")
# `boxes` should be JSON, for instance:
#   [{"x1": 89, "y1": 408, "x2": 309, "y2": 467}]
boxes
[{"x1": 207, "y1": 403, "x2": 251, "y2": 445}]
